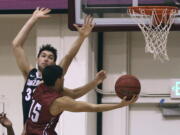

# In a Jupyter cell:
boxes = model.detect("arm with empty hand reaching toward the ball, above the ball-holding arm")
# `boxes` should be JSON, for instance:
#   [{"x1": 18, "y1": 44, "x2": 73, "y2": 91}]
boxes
[{"x1": 63, "y1": 70, "x2": 106, "y2": 99}]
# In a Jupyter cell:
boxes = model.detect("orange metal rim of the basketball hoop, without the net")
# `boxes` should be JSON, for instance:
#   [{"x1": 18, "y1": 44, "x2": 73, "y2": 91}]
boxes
[{"x1": 128, "y1": 6, "x2": 178, "y2": 15}]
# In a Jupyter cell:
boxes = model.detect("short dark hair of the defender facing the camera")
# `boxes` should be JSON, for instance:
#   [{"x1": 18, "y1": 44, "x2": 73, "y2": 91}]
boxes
[{"x1": 38, "y1": 44, "x2": 57, "y2": 62}]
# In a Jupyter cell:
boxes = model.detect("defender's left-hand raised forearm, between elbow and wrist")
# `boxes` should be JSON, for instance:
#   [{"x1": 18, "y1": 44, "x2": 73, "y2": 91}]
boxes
[{"x1": 12, "y1": 16, "x2": 37, "y2": 47}]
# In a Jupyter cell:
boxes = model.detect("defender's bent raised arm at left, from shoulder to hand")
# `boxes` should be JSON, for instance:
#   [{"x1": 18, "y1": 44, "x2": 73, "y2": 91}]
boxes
[{"x1": 12, "y1": 8, "x2": 51, "y2": 78}]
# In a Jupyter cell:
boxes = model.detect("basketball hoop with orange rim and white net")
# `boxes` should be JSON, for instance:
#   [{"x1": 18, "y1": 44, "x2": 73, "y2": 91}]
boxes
[{"x1": 128, "y1": 6, "x2": 178, "y2": 62}]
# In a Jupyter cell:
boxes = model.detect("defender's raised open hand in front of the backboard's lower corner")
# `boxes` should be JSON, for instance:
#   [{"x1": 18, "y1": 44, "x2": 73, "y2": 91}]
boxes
[{"x1": 74, "y1": 15, "x2": 95, "y2": 37}]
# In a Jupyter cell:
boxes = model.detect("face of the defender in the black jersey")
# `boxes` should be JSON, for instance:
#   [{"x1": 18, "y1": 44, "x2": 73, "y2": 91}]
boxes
[{"x1": 37, "y1": 51, "x2": 55, "y2": 71}]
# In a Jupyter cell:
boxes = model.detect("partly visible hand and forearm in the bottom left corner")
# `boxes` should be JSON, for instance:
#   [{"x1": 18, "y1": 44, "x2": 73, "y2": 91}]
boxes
[{"x1": 0, "y1": 113, "x2": 14, "y2": 135}]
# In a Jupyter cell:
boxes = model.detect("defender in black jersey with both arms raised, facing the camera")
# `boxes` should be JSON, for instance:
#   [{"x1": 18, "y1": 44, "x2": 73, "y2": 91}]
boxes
[{"x1": 12, "y1": 8, "x2": 94, "y2": 123}]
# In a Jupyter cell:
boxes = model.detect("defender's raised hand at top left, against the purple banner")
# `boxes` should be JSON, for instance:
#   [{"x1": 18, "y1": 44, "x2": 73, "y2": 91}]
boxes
[{"x1": 32, "y1": 7, "x2": 51, "y2": 19}]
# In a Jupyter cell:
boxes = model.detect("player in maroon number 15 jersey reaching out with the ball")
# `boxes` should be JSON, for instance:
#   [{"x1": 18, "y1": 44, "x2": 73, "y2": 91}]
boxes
[{"x1": 26, "y1": 65, "x2": 137, "y2": 135}]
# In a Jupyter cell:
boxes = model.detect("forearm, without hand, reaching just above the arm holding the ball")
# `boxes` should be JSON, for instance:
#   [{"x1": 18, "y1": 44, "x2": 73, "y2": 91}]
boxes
[{"x1": 73, "y1": 79, "x2": 98, "y2": 99}]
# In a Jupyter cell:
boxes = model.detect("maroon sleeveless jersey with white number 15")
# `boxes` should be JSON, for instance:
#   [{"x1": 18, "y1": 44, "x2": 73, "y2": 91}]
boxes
[{"x1": 26, "y1": 84, "x2": 62, "y2": 135}]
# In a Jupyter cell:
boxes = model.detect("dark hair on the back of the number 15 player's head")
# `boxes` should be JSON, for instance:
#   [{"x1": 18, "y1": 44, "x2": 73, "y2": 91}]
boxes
[{"x1": 42, "y1": 65, "x2": 63, "y2": 86}]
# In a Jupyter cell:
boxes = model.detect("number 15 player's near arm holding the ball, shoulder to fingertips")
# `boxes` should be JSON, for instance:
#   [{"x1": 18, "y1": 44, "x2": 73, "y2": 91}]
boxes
[{"x1": 50, "y1": 96, "x2": 138, "y2": 116}]
